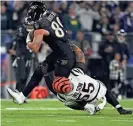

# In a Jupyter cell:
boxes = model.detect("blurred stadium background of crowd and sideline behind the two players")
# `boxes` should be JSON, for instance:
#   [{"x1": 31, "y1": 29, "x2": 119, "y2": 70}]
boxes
[{"x1": 0, "y1": 0, "x2": 133, "y2": 99}]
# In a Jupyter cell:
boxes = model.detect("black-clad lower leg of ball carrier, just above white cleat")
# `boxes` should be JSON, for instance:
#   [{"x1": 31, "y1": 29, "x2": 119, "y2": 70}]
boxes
[{"x1": 23, "y1": 64, "x2": 47, "y2": 97}]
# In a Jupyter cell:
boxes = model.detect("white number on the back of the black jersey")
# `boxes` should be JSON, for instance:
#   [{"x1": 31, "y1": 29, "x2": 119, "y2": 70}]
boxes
[{"x1": 51, "y1": 17, "x2": 64, "y2": 38}]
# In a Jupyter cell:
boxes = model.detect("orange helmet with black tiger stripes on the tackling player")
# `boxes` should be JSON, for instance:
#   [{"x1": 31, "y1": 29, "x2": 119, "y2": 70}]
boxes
[{"x1": 52, "y1": 77, "x2": 72, "y2": 94}]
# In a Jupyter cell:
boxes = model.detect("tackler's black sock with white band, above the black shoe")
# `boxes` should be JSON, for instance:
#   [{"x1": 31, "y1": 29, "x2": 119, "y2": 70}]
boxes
[{"x1": 105, "y1": 91, "x2": 121, "y2": 109}]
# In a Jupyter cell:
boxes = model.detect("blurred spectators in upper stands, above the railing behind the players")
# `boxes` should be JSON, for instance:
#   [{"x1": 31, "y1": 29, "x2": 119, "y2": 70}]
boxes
[{"x1": 1, "y1": 0, "x2": 133, "y2": 32}]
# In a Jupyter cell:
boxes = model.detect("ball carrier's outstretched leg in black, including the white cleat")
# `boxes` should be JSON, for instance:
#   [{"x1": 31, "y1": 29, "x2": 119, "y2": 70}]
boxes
[{"x1": 7, "y1": 61, "x2": 54, "y2": 104}]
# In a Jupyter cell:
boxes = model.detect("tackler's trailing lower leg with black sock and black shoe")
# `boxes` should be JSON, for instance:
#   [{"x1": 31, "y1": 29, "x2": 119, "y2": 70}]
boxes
[{"x1": 105, "y1": 90, "x2": 132, "y2": 114}]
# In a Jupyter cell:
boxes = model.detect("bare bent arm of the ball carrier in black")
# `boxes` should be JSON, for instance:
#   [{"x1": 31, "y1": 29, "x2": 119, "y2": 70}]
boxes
[{"x1": 27, "y1": 29, "x2": 50, "y2": 53}]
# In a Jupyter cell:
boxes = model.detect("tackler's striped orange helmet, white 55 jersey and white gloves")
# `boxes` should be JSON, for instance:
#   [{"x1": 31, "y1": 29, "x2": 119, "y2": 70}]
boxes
[{"x1": 53, "y1": 68, "x2": 107, "y2": 115}]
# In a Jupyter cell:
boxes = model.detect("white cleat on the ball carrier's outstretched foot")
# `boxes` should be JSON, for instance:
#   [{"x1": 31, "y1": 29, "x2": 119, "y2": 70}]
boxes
[{"x1": 7, "y1": 88, "x2": 26, "y2": 104}]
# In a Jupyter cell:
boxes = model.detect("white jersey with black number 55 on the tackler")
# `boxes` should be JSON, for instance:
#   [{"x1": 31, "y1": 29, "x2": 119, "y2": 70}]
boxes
[{"x1": 59, "y1": 68, "x2": 106, "y2": 102}]
